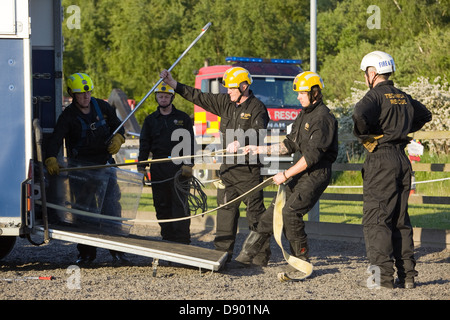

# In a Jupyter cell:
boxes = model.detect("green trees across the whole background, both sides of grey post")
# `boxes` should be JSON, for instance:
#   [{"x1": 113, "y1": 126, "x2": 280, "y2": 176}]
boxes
[{"x1": 62, "y1": 0, "x2": 450, "y2": 122}]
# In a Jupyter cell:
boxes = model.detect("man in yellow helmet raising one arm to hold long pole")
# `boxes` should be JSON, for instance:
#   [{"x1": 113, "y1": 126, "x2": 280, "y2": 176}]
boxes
[{"x1": 160, "y1": 67, "x2": 270, "y2": 265}]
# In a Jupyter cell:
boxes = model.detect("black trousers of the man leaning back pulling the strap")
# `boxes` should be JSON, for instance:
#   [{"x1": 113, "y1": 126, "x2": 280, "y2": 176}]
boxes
[{"x1": 257, "y1": 163, "x2": 331, "y2": 255}]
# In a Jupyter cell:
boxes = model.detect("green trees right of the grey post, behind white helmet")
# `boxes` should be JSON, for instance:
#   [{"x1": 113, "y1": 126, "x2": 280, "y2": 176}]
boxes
[{"x1": 318, "y1": 0, "x2": 449, "y2": 99}]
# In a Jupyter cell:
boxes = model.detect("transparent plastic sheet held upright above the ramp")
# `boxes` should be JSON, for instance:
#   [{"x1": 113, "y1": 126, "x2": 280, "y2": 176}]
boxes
[{"x1": 47, "y1": 160, "x2": 143, "y2": 235}]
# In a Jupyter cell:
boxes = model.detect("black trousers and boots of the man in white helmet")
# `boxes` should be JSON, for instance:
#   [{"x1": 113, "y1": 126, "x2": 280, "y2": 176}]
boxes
[{"x1": 362, "y1": 144, "x2": 417, "y2": 286}]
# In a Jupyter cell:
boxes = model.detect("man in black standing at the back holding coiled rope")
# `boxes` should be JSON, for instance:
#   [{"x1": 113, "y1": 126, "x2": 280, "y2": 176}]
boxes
[{"x1": 138, "y1": 83, "x2": 195, "y2": 244}]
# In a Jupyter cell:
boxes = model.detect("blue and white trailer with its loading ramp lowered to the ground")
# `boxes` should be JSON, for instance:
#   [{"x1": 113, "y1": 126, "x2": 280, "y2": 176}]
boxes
[{"x1": 0, "y1": 0, "x2": 227, "y2": 271}]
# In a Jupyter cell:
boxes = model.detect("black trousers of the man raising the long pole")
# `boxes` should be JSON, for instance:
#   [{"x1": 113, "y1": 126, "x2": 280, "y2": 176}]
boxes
[{"x1": 214, "y1": 164, "x2": 266, "y2": 259}]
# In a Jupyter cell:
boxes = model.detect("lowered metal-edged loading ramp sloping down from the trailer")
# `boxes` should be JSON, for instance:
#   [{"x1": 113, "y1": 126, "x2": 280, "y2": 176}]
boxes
[{"x1": 37, "y1": 226, "x2": 228, "y2": 271}]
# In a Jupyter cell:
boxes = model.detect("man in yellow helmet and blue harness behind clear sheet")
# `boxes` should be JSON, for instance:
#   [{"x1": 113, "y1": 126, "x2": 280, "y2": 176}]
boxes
[{"x1": 45, "y1": 73, "x2": 126, "y2": 263}]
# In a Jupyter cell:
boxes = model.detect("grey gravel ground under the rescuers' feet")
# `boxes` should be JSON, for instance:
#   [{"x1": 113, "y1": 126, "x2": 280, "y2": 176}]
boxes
[{"x1": 0, "y1": 227, "x2": 450, "y2": 306}]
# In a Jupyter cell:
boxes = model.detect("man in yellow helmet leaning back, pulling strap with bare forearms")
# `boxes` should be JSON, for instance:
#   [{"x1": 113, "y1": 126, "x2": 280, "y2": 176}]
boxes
[{"x1": 236, "y1": 71, "x2": 338, "y2": 272}]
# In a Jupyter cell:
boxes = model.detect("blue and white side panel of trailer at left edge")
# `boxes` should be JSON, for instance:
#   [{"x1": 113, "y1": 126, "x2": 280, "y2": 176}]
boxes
[{"x1": 0, "y1": 0, "x2": 32, "y2": 235}]
